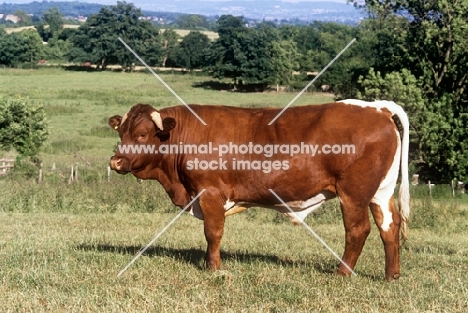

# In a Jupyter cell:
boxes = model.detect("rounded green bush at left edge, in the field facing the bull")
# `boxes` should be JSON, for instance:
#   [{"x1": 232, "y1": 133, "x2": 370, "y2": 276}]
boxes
[{"x1": 0, "y1": 97, "x2": 48, "y2": 156}]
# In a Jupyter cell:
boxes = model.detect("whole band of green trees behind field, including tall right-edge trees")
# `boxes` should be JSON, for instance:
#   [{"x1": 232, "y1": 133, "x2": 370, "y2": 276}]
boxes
[{"x1": 0, "y1": 0, "x2": 468, "y2": 182}]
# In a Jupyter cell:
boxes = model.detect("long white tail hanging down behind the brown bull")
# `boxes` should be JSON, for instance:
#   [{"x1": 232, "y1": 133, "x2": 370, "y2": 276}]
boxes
[{"x1": 393, "y1": 105, "x2": 410, "y2": 245}]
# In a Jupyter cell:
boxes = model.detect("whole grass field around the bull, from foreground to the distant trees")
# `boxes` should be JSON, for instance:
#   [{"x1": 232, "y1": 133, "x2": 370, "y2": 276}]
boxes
[{"x1": 0, "y1": 69, "x2": 468, "y2": 312}]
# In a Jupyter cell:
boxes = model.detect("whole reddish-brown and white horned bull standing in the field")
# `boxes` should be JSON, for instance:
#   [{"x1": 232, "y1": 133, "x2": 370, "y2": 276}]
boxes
[{"x1": 109, "y1": 100, "x2": 409, "y2": 280}]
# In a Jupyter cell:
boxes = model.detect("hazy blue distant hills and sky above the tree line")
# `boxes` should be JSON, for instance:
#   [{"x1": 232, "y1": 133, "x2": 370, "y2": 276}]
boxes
[{"x1": 0, "y1": 0, "x2": 362, "y2": 24}]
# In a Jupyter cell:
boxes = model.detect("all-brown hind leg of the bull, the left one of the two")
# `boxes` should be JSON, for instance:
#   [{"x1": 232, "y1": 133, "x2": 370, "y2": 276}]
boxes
[{"x1": 337, "y1": 197, "x2": 370, "y2": 276}]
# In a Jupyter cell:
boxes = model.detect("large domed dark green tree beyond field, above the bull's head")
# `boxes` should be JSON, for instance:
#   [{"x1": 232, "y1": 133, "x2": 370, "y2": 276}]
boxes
[{"x1": 69, "y1": 2, "x2": 161, "y2": 68}]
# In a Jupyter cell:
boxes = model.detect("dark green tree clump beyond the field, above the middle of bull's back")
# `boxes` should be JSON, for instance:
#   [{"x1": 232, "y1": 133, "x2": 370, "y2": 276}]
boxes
[{"x1": 207, "y1": 15, "x2": 299, "y2": 90}]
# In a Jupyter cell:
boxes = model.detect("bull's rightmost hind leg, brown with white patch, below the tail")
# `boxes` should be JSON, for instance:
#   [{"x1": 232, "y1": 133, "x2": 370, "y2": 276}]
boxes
[{"x1": 370, "y1": 197, "x2": 400, "y2": 281}]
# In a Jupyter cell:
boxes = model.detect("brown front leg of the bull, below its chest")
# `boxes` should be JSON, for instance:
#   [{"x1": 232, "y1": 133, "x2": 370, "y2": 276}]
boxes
[{"x1": 200, "y1": 191, "x2": 224, "y2": 270}]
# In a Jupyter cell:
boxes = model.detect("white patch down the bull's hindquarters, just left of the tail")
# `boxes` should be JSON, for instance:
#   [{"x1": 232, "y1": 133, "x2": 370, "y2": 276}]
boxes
[{"x1": 371, "y1": 131, "x2": 401, "y2": 231}]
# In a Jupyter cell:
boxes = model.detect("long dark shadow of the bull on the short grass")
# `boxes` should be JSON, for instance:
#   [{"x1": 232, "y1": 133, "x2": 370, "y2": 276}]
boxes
[{"x1": 77, "y1": 244, "x2": 337, "y2": 274}]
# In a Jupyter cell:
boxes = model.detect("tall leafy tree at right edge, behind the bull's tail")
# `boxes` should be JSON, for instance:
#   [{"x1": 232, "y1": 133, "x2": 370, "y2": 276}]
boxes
[{"x1": 353, "y1": 0, "x2": 468, "y2": 181}]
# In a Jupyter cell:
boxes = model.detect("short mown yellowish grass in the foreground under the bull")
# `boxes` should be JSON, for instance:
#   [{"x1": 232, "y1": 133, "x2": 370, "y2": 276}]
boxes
[{"x1": 0, "y1": 196, "x2": 468, "y2": 312}]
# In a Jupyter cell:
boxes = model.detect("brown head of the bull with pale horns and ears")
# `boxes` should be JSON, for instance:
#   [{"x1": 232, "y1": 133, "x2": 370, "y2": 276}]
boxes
[{"x1": 109, "y1": 104, "x2": 176, "y2": 178}]
